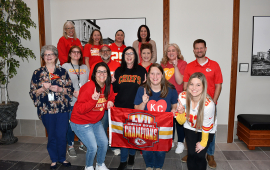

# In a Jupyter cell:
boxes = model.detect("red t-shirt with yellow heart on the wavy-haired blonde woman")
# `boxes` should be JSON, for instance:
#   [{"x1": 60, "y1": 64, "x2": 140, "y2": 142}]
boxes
[{"x1": 161, "y1": 59, "x2": 187, "y2": 94}]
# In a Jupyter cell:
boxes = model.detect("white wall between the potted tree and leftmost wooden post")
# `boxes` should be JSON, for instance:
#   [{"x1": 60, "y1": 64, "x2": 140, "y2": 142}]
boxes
[{"x1": 9, "y1": 0, "x2": 40, "y2": 119}]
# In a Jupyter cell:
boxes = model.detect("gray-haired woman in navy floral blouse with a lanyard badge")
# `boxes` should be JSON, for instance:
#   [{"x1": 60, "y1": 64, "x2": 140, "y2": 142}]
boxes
[{"x1": 29, "y1": 45, "x2": 74, "y2": 169}]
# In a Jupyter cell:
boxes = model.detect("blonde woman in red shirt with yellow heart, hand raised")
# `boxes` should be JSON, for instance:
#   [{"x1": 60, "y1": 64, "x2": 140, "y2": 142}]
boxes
[{"x1": 161, "y1": 43, "x2": 187, "y2": 154}]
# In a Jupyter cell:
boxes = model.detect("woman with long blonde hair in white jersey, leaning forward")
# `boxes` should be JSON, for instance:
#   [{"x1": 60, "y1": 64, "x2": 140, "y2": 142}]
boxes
[{"x1": 176, "y1": 72, "x2": 216, "y2": 170}]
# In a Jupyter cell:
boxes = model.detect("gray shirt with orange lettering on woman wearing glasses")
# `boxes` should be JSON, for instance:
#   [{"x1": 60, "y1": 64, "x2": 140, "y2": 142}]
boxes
[{"x1": 62, "y1": 63, "x2": 89, "y2": 106}]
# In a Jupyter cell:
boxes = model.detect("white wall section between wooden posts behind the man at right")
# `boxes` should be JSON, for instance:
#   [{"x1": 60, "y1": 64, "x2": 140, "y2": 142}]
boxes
[{"x1": 170, "y1": 0, "x2": 233, "y2": 124}]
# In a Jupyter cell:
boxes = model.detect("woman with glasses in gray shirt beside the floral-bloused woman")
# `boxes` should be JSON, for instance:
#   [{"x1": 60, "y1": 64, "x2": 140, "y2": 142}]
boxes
[{"x1": 62, "y1": 46, "x2": 89, "y2": 157}]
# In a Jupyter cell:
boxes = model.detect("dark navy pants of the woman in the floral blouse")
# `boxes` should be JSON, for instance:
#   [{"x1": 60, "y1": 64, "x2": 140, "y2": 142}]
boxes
[{"x1": 41, "y1": 112, "x2": 68, "y2": 162}]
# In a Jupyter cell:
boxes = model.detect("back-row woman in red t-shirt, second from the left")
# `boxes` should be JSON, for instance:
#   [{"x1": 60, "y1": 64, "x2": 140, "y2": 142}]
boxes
[{"x1": 83, "y1": 29, "x2": 103, "y2": 70}]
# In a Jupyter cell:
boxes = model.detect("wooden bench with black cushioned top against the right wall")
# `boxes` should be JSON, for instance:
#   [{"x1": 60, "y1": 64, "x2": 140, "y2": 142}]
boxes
[{"x1": 237, "y1": 114, "x2": 270, "y2": 150}]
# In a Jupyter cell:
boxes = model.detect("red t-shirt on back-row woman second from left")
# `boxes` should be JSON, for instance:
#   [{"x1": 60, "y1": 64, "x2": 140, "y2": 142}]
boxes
[{"x1": 83, "y1": 44, "x2": 102, "y2": 68}]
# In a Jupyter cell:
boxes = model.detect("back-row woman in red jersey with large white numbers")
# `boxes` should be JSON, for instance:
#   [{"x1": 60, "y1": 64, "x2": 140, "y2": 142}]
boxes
[{"x1": 110, "y1": 29, "x2": 126, "y2": 63}]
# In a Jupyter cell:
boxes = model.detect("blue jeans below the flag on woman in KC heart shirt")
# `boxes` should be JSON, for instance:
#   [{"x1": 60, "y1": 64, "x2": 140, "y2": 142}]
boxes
[{"x1": 142, "y1": 151, "x2": 166, "y2": 169}]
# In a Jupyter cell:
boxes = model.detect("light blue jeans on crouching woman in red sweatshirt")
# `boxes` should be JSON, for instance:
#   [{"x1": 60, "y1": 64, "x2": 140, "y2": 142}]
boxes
[{"x1": 70, "y1": 121, "x2": 108, "y2": 167}]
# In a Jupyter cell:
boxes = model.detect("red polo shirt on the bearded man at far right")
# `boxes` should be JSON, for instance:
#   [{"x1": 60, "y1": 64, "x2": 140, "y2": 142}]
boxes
[{"x1": 183, "y1": 57, "x2": 223, "y2": 98}]
